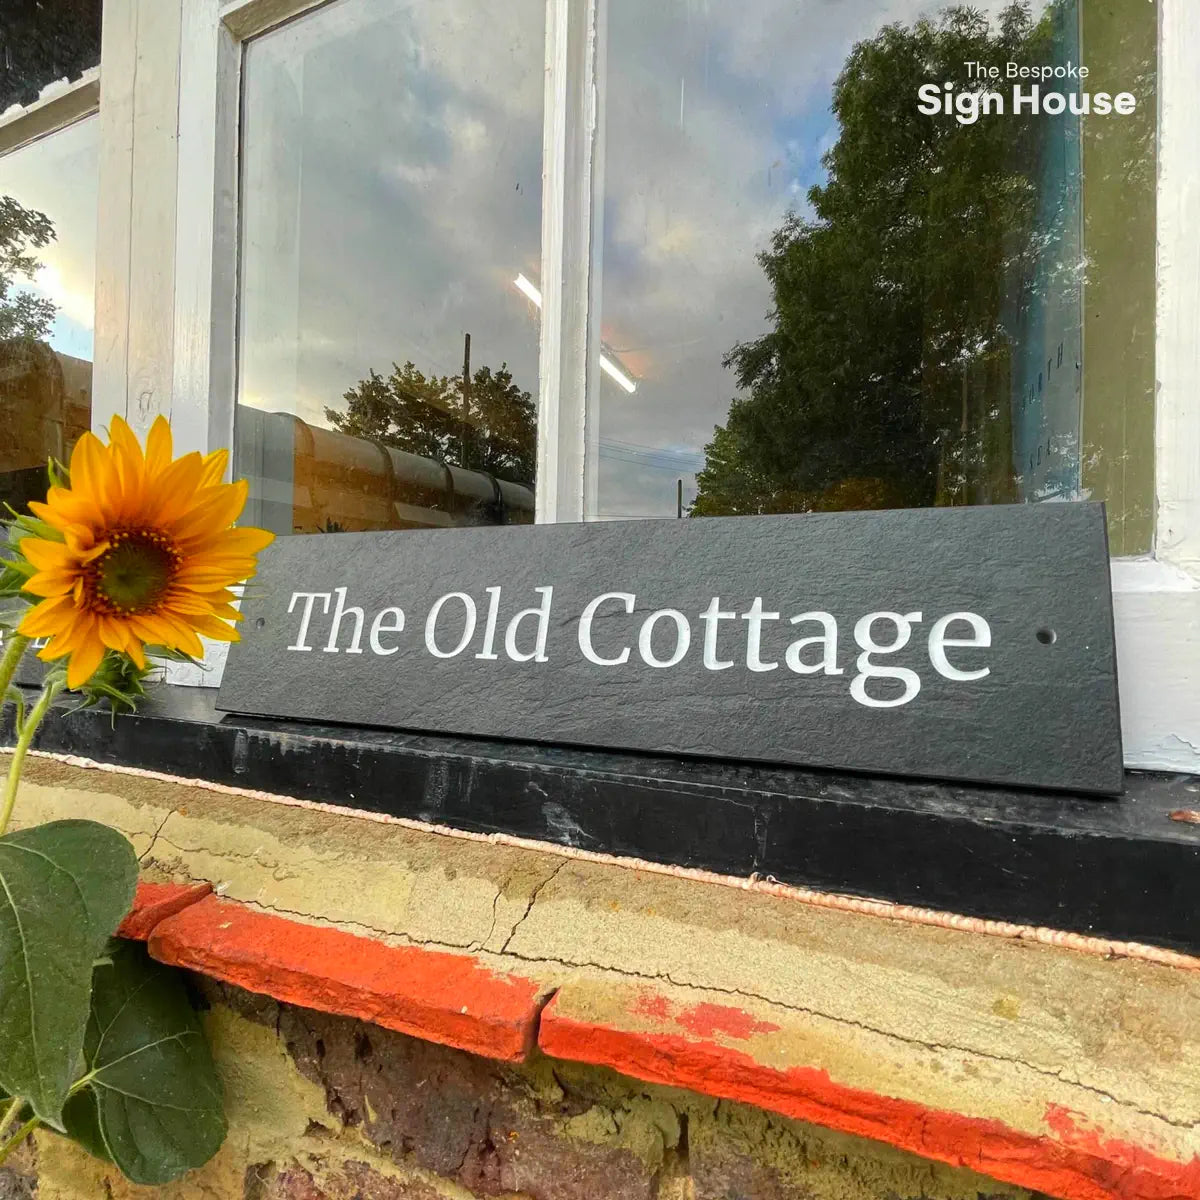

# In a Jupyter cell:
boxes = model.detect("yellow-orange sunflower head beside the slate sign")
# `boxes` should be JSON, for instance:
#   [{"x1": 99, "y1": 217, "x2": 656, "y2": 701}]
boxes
[{"x1": 17, "y1": 416, "x2": 275, "y2": 688}]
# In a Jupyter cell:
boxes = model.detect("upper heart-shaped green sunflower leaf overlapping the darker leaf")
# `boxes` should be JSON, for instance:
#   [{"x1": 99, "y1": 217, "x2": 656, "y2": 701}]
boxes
[{"x1": 0, "y1": 821, "x2": 138, "y2": 1126}]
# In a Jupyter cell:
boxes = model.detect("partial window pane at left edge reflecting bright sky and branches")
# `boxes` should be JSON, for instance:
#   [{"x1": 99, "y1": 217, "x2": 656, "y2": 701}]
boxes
[{"x1": 0, "y1": 116, "x2": 98, "y2": 518}]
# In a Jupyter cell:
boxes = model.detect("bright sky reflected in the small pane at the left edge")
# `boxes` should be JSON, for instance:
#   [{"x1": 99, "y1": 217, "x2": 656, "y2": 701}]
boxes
[{"x1": 0, "y1": 116, "x2": 100, "y2": 362}]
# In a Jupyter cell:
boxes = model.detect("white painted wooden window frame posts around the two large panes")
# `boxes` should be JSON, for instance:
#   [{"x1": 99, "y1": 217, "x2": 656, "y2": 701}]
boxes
[{"x1": 82, "y1": 0, "x2": 1200, "y2": 773}]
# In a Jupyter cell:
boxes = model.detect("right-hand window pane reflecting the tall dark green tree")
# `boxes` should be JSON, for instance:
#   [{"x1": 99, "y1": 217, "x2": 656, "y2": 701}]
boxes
[{"x1": 590, "y1": 0, "x2": 1157, "y2": 553}]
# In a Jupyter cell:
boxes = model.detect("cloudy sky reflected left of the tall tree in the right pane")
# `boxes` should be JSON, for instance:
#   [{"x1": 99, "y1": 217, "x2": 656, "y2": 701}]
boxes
[{"x1": 598, "y1": 0, "x2": 1041, "y2": 517}]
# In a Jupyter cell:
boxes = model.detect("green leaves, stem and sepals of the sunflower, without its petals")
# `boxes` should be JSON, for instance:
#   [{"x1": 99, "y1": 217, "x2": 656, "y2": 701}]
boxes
[{"x1": 0, "y1": 415, "x2": 226, "y2": 1184}]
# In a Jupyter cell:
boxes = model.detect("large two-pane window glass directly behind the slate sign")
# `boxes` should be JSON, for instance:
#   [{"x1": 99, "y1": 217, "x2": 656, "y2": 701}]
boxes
[{"x1": 225, "y1": 0, "x2": 1157, "y2": 554}]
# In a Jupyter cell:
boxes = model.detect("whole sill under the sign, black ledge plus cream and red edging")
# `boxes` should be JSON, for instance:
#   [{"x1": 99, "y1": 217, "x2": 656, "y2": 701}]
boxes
[{"x1": 7, "y1": 689, "x2": 1200, "y2": 1200}]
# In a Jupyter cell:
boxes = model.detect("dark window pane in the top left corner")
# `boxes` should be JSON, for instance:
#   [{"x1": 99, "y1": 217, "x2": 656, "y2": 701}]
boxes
[{"x1": 0, "y1": 0, "x2": 103, "y2": 113}]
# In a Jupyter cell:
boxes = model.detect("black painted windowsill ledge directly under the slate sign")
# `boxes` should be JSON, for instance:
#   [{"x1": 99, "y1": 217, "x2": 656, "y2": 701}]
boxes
[{"x1": 0, "y1": 686, "x2": 1200, "y2": 953}]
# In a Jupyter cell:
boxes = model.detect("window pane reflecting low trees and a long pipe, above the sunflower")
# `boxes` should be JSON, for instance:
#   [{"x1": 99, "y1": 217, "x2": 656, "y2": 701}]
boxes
[{"x1": 236, "y1": 0, "x2": 545, "y2": 533}]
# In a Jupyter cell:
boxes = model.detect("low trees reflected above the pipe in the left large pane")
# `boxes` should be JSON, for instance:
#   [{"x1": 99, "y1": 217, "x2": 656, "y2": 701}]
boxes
[{"x1": 325, "y1": 362, "x2": 538, "y2": 485}]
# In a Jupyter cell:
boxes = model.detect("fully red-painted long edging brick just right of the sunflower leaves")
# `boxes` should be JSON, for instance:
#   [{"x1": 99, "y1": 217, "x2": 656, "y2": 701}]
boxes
[{"x1": 150, "y1": 896, "x2": 546, "y2": 1062}]
